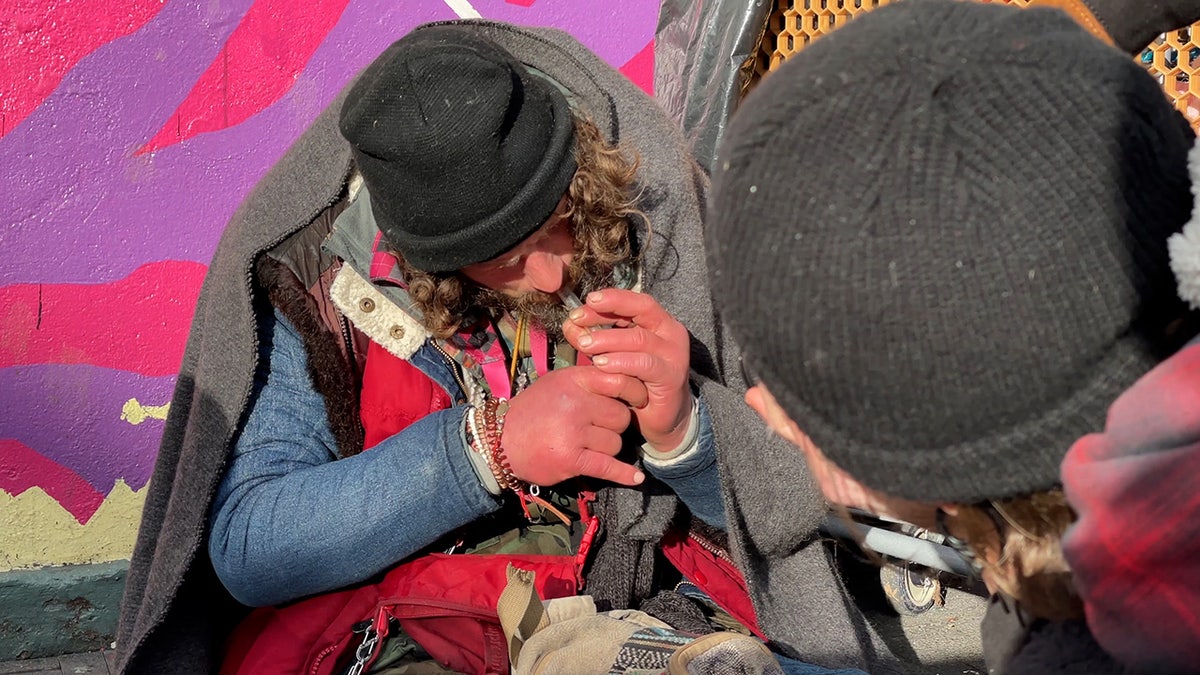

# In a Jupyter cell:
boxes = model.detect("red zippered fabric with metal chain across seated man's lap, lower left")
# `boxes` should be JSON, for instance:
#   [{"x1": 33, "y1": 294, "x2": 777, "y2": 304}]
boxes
[{"x1": 221, "y1": 554, "x2": 578, "y2": 675}]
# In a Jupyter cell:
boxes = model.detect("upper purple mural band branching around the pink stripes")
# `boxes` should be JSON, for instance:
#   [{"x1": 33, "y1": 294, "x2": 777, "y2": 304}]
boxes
[{"x1": 0, "y1": 0, "x2": 656, "y2": 285}]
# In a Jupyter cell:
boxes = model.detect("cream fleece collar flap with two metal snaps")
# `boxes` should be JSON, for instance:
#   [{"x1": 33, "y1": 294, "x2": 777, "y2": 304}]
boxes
[{"x1": 329, "y1": 264, "x2": 430, "y2": 360}]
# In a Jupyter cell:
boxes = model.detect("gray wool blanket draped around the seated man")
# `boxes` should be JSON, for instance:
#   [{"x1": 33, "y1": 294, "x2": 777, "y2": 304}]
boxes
[{"x1": 118, "y1": 22, "x2": 895, "y2": 675}]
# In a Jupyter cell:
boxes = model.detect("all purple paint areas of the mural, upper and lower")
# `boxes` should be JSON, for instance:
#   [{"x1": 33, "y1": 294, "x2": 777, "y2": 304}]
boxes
[{"x1": 0, "y1": 0, "x2": 658, "y2": 504}]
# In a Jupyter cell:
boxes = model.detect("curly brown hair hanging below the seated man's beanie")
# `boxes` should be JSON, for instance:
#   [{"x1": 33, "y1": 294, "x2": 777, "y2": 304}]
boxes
[{"x1": 392, "y1": 114, "x2": 648, "y2": 339}]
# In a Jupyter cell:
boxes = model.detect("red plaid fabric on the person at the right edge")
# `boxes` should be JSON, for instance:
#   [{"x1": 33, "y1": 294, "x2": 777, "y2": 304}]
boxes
[{"x1": 1062, "y1": 341, "x2": 1200, "y2": 673}]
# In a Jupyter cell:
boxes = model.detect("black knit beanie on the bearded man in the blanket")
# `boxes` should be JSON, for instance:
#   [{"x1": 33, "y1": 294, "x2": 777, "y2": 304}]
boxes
[{"x1": 340, "y1": 25, "x2": 576, "y2": 271}]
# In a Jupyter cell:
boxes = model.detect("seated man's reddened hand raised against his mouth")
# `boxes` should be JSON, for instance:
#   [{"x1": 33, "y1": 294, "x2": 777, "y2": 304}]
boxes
[{"x1": 563, "y1": 288, "x2": 691, "y2": 452}]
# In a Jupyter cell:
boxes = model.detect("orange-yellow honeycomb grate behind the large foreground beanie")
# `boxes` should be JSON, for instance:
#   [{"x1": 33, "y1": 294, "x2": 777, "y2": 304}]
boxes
[{"x1": 755, "y1": 0, "x2": 1200, "y2": 131}]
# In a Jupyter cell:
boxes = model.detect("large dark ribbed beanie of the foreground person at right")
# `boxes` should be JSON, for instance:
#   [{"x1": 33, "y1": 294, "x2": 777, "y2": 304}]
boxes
[{"x1": 706, "y1": 0, "x2": 1192, "y2": 503}]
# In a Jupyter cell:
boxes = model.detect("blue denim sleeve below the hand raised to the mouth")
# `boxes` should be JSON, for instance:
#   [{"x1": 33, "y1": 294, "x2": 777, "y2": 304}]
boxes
[{"x1": 646, "y1": 394, "x2": 725, "y2": 530}]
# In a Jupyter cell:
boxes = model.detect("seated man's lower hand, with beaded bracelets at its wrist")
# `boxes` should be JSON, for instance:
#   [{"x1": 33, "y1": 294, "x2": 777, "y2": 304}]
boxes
[{"x1": 502, "y1": 366, "x2": 647, "y2": 485}]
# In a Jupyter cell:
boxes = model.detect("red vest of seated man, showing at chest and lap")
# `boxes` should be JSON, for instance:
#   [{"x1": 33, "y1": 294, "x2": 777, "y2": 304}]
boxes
[{"x1": 221, "y1": 342, "x2": 758, "y2": 675}]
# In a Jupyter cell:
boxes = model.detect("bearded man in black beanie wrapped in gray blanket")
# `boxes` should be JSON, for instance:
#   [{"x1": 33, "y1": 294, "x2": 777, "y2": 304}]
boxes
[{"x1": 118, "y1": 22, "x2": 897, "y2": 674}]
